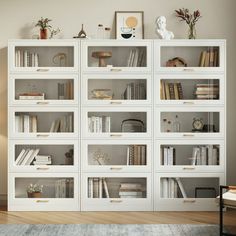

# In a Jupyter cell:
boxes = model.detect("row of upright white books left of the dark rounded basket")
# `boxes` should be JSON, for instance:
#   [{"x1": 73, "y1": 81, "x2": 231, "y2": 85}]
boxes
[{"x1": 88, "y1": 116, "x2": 111, "y2": 133}]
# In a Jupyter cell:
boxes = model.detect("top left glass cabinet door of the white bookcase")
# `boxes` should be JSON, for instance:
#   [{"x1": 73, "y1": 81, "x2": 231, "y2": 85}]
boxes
[{"x1": 9, "y1": 40, "x2": 79, "y2": 73}]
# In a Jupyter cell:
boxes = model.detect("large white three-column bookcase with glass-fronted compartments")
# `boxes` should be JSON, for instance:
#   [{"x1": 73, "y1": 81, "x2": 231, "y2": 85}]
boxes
[{"x1": 8, "y1": 40, "x2": 226, "y2": 211}]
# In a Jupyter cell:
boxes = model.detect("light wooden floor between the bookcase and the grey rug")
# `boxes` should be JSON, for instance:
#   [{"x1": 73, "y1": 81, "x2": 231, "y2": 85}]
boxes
[{"x1": 0, "y1": 208, "x2": 236, "y2": 230}]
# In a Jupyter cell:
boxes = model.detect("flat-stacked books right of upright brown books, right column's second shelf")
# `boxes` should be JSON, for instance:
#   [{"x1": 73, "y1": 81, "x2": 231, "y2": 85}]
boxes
[{"x1": 194, "y1": 84, "x2": 219, "y2": 99}]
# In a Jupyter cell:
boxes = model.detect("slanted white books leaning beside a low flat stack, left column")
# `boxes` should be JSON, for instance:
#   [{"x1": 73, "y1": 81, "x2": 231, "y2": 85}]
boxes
[{"x1": 15, "y1": 148, "x2": 39, "y2": 166}]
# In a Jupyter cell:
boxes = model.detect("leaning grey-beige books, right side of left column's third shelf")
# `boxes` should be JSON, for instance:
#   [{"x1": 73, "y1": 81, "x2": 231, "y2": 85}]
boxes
[{"x1": 49, "y1": 115, "x2": 73, "y2": 133}]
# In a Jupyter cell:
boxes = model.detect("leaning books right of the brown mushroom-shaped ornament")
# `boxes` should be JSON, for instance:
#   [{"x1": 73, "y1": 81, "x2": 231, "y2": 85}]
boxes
[{"x1": 127, "y1": 48, "x2": 146, "y2": 67}]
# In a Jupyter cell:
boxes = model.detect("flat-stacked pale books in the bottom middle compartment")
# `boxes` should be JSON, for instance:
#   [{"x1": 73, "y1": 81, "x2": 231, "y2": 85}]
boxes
[{"x1": 119, "y1": 183, "x2": 144, "y2": 198}]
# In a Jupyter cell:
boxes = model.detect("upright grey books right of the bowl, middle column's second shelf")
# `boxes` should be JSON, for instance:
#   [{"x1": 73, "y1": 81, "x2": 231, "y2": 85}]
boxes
[{"x1": 124, "y1": 82, "x2": 146, "y2": 100}]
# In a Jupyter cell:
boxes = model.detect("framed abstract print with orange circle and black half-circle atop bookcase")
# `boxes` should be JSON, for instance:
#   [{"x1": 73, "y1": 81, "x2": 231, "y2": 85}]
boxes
[{"x1": 115, "y1": 11, "x2": 144, "y2": 39}]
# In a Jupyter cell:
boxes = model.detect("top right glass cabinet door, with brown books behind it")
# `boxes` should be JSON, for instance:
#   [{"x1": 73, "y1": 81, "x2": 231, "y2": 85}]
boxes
[{"x1": 154, "y1": 40, "x2": 225, "y2": 73}]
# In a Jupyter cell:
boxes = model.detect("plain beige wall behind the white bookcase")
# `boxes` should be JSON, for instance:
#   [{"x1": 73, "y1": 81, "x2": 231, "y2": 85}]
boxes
[{"x1": 0, "y1": 0, "x2": 236, "y2": 199}]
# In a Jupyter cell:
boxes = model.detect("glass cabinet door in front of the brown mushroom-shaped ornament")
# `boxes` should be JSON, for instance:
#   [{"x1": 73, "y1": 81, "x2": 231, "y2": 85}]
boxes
[{"x1": 82, "y1": 40, "x2": 151, "y2": 73}]
